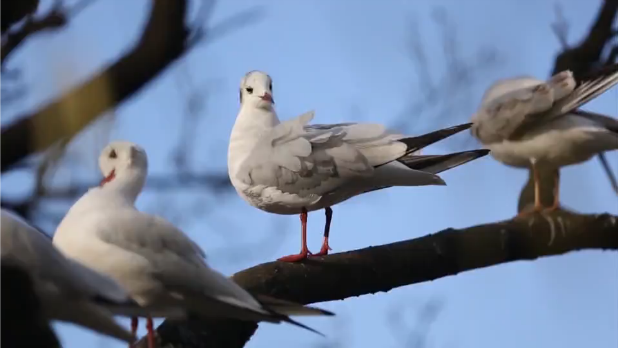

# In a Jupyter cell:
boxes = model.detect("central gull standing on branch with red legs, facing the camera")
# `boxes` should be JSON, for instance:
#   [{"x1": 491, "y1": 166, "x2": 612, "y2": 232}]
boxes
[{"x1": 228, "y1": 70, "x2": 489, "y2": 262}]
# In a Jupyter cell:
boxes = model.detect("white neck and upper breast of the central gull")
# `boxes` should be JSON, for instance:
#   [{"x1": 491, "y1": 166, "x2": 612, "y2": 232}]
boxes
[{"x1": 227, "y1": 105, "x2": 280, "y2": 174}]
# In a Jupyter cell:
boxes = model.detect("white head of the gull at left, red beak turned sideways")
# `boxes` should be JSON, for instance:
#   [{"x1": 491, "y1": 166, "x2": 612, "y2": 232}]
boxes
[{"x1": 99, "y1": 141, "x2": 148, "y2": 201}]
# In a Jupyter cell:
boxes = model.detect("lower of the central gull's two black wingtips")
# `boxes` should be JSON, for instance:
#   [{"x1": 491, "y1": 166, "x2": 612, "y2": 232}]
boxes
[{"x1": 398, "y1": 149, "x2": 489, "y2": 174}]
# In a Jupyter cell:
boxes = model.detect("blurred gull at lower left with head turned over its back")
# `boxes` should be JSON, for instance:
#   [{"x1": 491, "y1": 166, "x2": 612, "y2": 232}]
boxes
[{"x1": 53, "y1": 141, "x2": 333, "y2": 348}]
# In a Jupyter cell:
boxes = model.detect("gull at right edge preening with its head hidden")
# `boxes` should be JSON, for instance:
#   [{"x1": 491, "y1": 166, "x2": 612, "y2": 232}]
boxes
[{"x1": 470, "y1": 64, "x2": 618, "y2": 217}]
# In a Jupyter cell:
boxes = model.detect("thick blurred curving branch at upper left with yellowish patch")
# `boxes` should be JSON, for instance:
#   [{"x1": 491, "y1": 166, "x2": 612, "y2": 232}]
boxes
[{"x1": 0, "y1": 0, "x2": 188, "y2": 172}]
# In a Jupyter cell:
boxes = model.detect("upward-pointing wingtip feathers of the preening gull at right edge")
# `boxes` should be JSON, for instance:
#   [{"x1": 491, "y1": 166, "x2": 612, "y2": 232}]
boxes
[{"x1": 554, "y1": 64, "x2": 618, "y2": 116}]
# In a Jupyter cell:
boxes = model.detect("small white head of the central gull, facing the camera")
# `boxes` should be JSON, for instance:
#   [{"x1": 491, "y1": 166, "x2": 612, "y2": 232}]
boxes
[{"x1": 240, "y1": 70, "x2": 275, "y2": 110}]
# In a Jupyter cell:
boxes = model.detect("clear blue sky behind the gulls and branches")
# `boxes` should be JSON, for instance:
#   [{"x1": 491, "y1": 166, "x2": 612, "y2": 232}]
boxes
[{"x1": 0, "y1": 0, "x2": 618, "y2": 348}]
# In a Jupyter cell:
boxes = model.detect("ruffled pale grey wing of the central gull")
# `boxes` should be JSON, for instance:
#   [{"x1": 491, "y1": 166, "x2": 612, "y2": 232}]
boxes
[{"x1": 239, "y1": 112, "x2": 406, "y2": 196}]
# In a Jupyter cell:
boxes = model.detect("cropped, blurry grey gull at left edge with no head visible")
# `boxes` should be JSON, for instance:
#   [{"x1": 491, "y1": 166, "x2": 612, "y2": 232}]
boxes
[{"x1": 0, "y1": 208, "x2": 141, "y2": 343}]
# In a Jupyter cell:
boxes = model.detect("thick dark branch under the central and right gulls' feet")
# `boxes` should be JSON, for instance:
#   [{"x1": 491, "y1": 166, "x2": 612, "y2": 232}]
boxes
[{"x1": 139, "y1": 212, "x2": 618, "y2": 348}]
